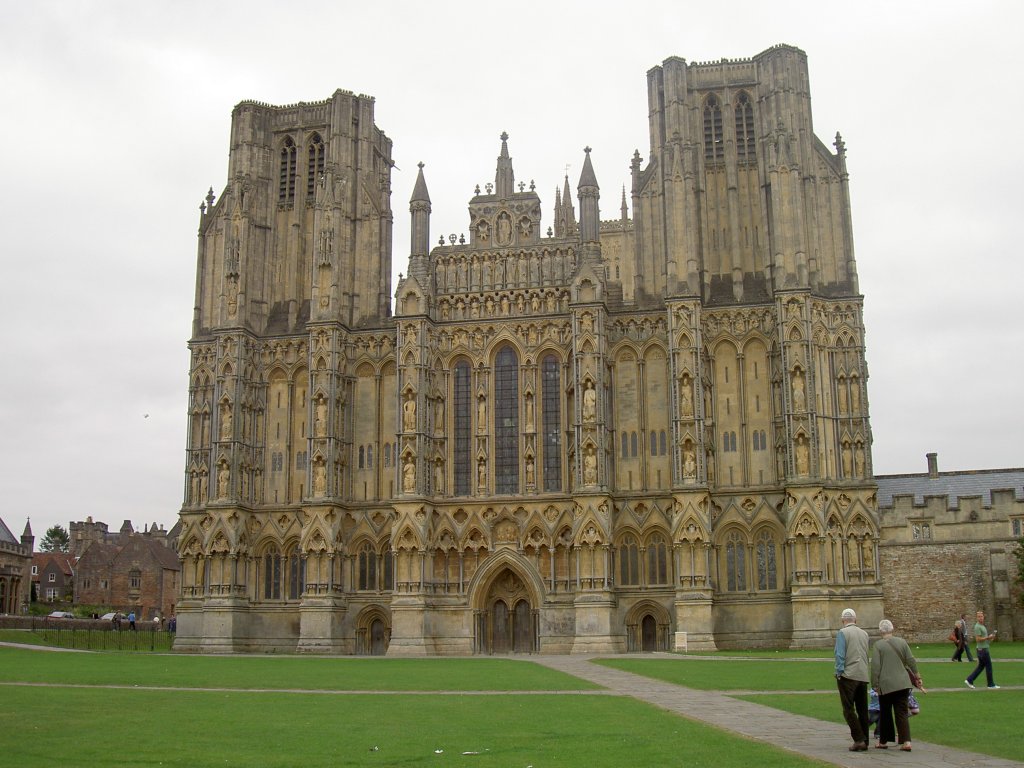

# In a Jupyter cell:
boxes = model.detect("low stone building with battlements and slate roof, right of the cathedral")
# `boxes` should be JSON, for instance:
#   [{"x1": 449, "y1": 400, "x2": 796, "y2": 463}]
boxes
[{"x1": 874, "y1": 454, "x2": 1024, "y2": 642}]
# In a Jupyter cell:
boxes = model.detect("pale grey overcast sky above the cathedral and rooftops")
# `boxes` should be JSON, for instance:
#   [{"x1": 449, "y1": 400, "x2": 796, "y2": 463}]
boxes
[{"x1": 0, "y1": 0, "x2": 1024, "y2": 545}]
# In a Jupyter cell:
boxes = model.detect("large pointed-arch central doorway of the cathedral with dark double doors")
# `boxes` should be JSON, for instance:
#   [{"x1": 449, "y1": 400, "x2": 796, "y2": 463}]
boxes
[{"x1": 476, "y1": 568, "x2": 538, "y2": 653}]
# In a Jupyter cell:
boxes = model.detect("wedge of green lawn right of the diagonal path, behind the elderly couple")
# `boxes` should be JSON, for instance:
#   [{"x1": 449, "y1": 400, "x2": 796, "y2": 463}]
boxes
[{"x1": 739, "y1": 692, "x2": 1024, "y2": 760}]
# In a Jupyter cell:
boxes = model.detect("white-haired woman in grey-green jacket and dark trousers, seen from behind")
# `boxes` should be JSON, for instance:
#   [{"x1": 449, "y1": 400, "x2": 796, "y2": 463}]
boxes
[{"x1": 871, "y1": 618, "x2": 921, "y2": 752}]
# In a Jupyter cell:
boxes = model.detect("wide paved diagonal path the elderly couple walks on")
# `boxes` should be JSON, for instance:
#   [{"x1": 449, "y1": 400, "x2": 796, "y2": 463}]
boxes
[{"x1": 530, "y1": 654, "x2": 1024, "y2": 768}]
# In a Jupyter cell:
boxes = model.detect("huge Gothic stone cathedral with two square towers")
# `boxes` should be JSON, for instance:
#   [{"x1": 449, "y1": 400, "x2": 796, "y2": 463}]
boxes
[{"x1": 175, "y1": 45, "x2": 883, "y2": 655}]
